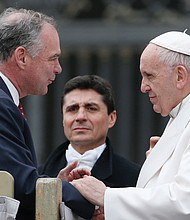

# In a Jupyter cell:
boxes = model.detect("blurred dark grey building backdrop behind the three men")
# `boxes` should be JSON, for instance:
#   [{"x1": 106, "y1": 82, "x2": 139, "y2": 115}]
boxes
[{"x1": 0, "y1": 0, "x2": 190, "y2": 164}]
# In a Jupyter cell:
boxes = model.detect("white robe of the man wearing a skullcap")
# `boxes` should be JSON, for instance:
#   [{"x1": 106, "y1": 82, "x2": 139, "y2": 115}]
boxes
[{"x1": 104, "y1": 95, "x2": 190, "y2": 220}]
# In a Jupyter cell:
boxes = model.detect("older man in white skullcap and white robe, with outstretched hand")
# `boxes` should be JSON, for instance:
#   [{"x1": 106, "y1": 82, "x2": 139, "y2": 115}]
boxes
[{"x1": 72, "y1": 31, "x2": 190, "y2": 220}]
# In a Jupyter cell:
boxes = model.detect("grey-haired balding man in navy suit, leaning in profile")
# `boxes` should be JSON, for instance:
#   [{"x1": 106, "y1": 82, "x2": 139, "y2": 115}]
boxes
[{"x1": 0, "y1": 8, "x2": 94, "y2": 220}]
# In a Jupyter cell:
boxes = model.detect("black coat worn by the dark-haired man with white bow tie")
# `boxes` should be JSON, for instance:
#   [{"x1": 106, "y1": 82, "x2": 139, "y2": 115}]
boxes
[{"x1": 40, "y1": 138, "x2": 140, "y2": 187}]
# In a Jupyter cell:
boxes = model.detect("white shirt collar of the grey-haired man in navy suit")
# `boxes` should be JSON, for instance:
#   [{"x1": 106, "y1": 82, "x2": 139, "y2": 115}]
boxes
[{"x1": 0, "y1": 72, "x2": 19, "y2": 106}]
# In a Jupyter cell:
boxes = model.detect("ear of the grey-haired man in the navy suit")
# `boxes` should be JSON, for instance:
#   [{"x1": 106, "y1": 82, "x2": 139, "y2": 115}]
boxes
[{"x1": 14, "y1": 46, "x2": 27, "y2": 69}]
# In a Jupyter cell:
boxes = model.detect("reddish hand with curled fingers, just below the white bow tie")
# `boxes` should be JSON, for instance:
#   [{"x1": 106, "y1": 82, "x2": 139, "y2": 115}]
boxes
[{"x1": 57, "y1": 161, "x2": 91, "y2": 182}]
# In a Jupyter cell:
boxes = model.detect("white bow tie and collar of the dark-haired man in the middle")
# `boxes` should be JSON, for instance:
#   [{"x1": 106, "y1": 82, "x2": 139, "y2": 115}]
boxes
[{"x1": 65, "y1": 143, "x2": 106, "y2": 170}]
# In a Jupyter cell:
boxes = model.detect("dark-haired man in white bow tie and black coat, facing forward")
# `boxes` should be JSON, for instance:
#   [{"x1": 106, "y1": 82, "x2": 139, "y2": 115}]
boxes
[{"x1": 41, "y1": 75, "x2": 140, "y2": 218}]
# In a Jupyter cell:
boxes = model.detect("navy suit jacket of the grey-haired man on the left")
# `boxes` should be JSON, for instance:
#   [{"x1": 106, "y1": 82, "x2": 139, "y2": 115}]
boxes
[{"x1": 0, "y1": 77, "x2": 94, "y2": 220}]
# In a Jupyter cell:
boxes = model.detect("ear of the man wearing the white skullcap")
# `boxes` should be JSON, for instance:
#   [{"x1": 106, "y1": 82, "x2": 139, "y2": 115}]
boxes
[{"x1": 175, "y1": 65, "x2": 189, "y2": 89}]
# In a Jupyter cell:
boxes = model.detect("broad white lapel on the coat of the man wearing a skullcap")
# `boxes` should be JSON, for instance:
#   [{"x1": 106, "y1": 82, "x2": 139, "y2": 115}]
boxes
[{"x1": 137, "y1": 97, "x2": 190, "y2": 187}]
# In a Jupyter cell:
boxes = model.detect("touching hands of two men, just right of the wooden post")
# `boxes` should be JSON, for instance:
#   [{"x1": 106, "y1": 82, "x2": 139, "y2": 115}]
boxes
[{"x1": 57, "y1": 161, "x2": 106, "y2": 220}]
